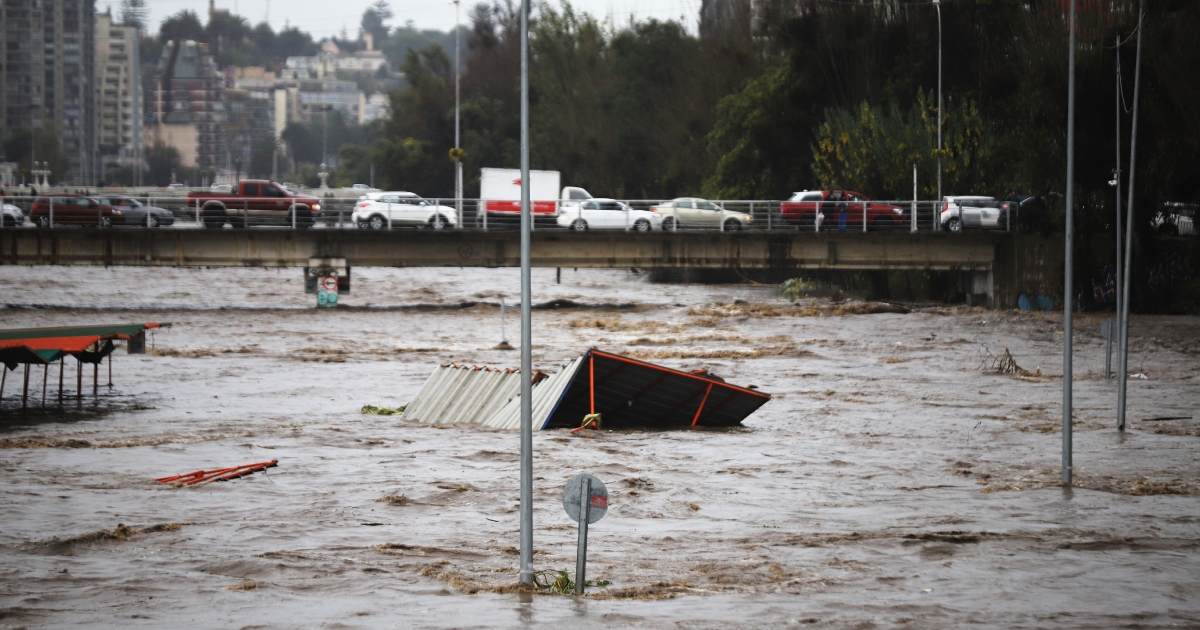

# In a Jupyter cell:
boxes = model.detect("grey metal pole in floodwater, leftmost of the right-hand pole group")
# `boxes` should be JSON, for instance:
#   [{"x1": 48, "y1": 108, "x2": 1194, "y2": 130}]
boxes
[{"x1": 1062, "y1": 0, "x2": 1075, "y2": 486}]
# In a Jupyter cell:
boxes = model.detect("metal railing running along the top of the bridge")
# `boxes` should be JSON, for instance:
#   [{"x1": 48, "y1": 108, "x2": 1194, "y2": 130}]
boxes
[{"x1": 0, "y1": 191, "x2": 1020, "y2": 234}]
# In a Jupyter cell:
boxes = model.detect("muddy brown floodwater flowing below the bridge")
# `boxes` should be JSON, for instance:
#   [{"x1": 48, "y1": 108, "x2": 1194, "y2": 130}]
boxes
[{"x1": 0, "y1": 266, "x2": 1200, "y2": 628}]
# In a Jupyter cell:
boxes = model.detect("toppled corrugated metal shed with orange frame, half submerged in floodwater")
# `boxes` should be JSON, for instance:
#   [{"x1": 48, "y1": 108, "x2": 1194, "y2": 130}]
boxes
[{"x1": 404, "y1": 348, "x2": 770, "y2": 430}]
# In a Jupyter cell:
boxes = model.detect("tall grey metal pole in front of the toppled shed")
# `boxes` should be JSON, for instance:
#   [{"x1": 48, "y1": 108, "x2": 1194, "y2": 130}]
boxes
[{"x1": 520, "y1": 0, "x2": 533, "y2": 584}]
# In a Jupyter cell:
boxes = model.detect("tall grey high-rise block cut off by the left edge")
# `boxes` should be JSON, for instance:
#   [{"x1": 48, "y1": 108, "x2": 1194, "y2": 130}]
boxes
[{"x1": 0, "y1": 0, "x2": 97, "y2": 185}]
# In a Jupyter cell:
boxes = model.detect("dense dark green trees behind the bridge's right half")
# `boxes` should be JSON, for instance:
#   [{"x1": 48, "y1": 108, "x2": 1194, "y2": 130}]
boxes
[{"x1": 370, "y1": 0, "x2": 1200, "y2": 223}]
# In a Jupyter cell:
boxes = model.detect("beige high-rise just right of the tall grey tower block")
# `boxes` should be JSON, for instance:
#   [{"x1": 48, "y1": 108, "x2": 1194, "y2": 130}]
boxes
[{"x1": 96, "y1": 12, "x2": 142, "y2": 184}]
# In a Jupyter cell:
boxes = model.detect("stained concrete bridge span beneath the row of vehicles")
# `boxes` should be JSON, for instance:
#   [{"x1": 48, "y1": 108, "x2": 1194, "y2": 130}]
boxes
[{"x1": 0, "y1": 228, "x2": 1062, "y2": 306}]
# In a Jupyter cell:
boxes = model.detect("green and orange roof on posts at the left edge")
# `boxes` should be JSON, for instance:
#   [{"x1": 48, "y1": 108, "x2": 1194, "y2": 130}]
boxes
[{"x1": 0, "y1": 323, "x2": 170, "y2": 370}]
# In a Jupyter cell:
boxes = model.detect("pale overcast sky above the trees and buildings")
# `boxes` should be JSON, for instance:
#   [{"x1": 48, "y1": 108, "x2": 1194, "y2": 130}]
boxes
[{"x1": 132, "y1": 0, "x2": 701, "y2": 41}]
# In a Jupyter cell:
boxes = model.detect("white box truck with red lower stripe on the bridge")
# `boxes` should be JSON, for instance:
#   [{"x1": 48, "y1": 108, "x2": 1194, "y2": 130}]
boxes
[{"x1": 478, "y1": 168, "x2": 592, "y2": 227}]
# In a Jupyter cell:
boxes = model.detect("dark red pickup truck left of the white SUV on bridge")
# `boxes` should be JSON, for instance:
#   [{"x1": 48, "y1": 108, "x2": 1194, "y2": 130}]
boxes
[{"x1": 187, "y1": 179, "x2": 322, "y2": 228}]
